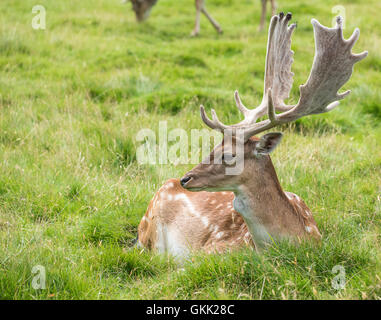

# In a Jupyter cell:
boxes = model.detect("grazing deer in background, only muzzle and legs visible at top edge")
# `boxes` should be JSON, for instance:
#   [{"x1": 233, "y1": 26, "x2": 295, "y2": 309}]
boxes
[{"x1": 123, "y1": 0, "x2": 276, "y2": 36}]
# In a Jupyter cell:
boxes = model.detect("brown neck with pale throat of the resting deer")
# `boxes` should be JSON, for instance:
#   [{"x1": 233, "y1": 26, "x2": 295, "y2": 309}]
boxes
[{"x1": 233, "y1": 161, "x2": 301, "y2": 247}]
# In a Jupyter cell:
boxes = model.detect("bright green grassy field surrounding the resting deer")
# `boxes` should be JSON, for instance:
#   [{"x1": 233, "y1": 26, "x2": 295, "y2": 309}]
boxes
[{"x1": 0, "y1": 0, "x2": 381, "y2": 299}]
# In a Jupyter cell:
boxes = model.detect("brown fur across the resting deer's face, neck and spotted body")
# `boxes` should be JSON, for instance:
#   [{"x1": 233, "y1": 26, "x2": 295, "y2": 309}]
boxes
[{"x1": 138, "y1": 137, "x2": 321, "y2": 252}]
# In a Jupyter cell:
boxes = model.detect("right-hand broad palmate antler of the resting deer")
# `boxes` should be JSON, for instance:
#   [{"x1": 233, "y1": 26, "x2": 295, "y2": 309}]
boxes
[{"x1": 239, "y1": 17, "x2": 368, "y2": 138}]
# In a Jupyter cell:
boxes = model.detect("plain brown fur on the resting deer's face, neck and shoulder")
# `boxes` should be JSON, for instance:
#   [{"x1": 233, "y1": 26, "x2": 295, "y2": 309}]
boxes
[{"x1": 180, "y1": 133, "x2": 321, "y2": 247}]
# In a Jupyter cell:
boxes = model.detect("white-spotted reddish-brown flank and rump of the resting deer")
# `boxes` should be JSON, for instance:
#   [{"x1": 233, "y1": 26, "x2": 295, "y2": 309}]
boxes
[{"x1": 138, "y1": 179, "x2": 253, "y2": 252}]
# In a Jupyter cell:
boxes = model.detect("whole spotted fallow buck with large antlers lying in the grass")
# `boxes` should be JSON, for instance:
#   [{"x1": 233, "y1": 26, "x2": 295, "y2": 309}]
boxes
[{"x1": 138, "y1": 13, "x2": 367, "y2": 256}]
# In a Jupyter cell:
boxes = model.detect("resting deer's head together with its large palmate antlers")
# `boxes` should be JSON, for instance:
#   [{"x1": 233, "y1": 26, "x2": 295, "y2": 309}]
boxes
[{"x1": 181, "y1": 13, "x2": 367, "y2": 191}]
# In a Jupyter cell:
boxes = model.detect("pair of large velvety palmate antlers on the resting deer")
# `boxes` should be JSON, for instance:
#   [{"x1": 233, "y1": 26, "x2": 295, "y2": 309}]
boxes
[{"x1": 200, "y1": 13, "x2": 368, "y2": 140}]
